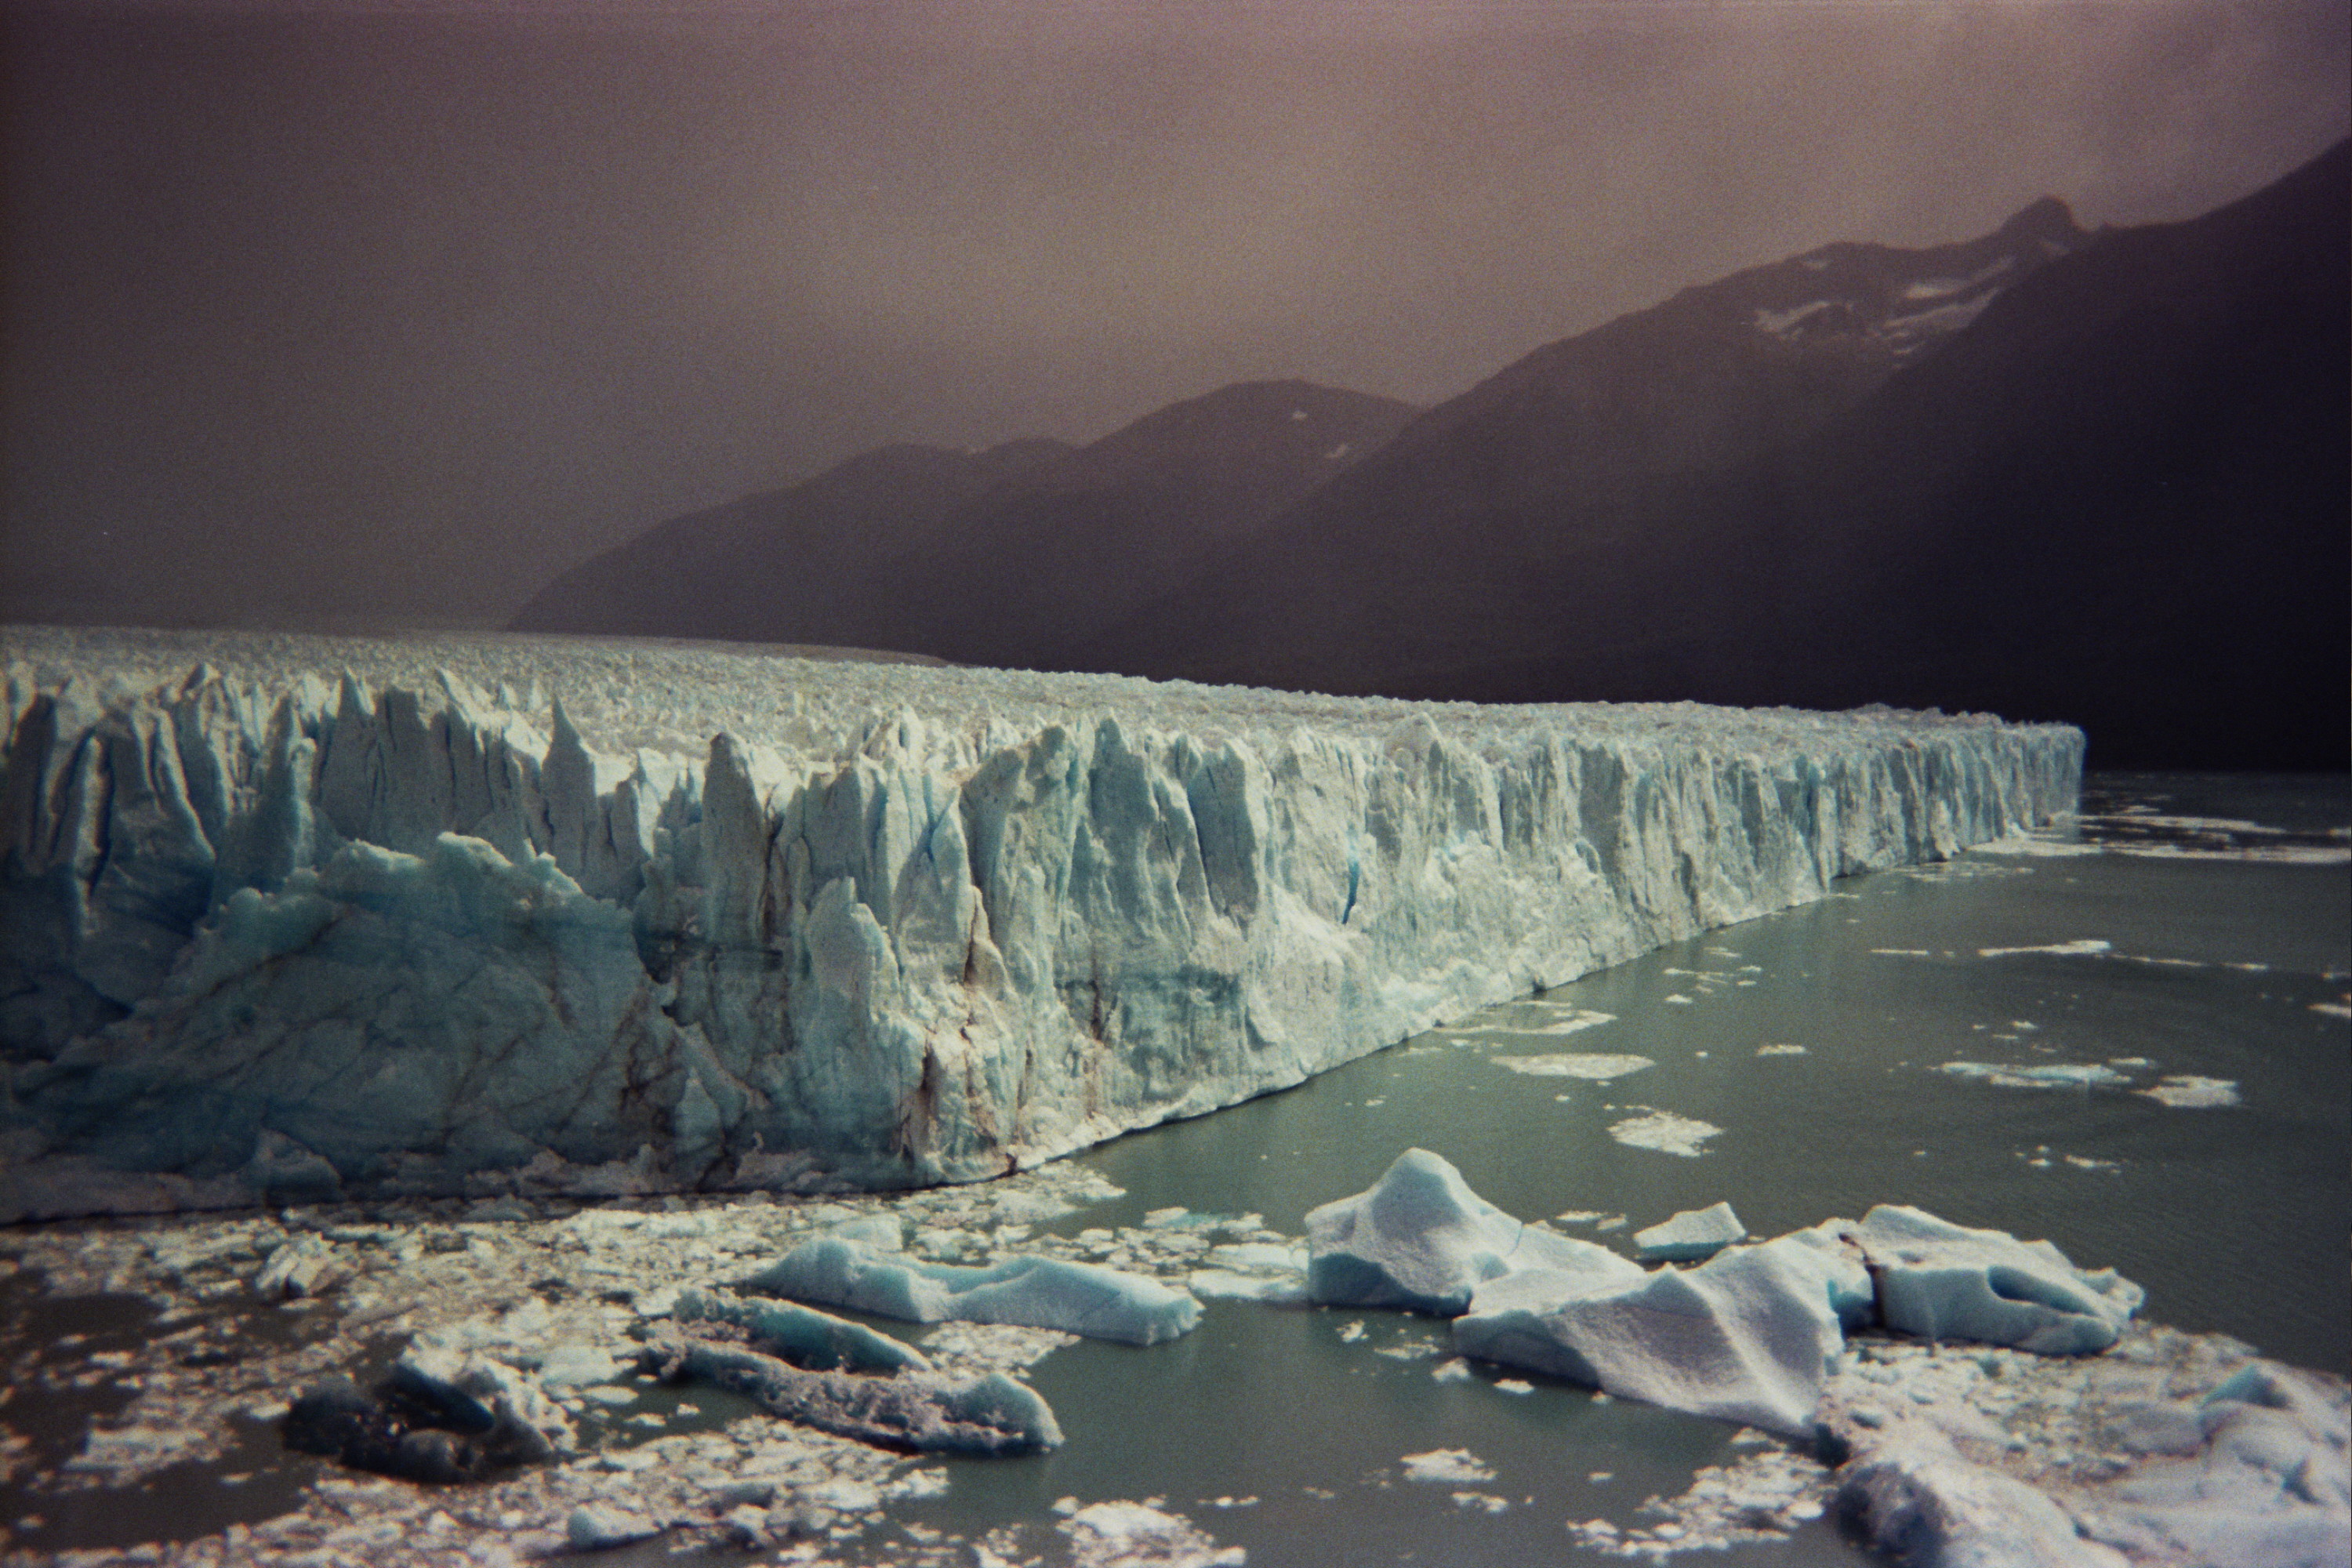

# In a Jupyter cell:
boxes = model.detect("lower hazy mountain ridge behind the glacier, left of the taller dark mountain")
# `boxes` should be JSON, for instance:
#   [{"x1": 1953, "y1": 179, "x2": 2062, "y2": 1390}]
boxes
[{"x1": 513, "y1": 381, "x2": 1414, "y2": 668}]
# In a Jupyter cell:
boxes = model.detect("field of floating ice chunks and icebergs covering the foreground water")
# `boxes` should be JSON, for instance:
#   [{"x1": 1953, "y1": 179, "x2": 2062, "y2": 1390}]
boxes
[{"x1": 9, "y1": 1149, "x2": 2352, "y2": 1568}]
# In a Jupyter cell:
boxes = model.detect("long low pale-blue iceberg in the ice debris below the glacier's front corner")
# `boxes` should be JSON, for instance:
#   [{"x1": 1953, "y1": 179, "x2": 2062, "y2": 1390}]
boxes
[{"x1": 743, "y1": 1236, "x2": 1200, "y2": 1345}]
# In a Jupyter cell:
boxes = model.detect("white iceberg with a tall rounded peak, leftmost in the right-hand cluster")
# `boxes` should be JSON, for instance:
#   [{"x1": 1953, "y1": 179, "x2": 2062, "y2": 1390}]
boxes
[{"x1": 1308, "y1": 1149, "x2": 1642, "y2": 1316}]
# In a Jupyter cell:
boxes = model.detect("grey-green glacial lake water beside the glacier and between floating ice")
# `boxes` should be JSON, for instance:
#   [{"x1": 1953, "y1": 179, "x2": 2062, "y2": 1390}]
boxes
[{"x1": 9, "y1": 776, "x2": 2352, "y2": 1568}]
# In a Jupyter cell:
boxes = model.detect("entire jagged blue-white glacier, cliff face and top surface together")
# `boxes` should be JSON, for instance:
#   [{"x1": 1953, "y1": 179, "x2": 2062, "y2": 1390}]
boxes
[{"x1": 0, "y1": 628, "x2": 2082, "y2": 1215}]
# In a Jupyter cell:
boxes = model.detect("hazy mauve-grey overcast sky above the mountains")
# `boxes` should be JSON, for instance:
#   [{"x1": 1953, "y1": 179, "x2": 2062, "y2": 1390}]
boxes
[{"x1": 0, "y1": 0, "x2": 2352, "y2": 630}]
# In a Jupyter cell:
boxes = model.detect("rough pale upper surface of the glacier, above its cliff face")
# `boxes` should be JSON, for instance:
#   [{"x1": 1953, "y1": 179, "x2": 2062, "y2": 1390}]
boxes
[{"x1": 0, "y1": 626, "x2": 2063, "y2": 757}]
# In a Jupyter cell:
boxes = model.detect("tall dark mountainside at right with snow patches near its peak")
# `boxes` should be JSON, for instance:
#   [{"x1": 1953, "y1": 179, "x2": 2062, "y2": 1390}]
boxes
[{"x1": 1082, "y1": 146, "x2": 2352, "y2": 769}]
